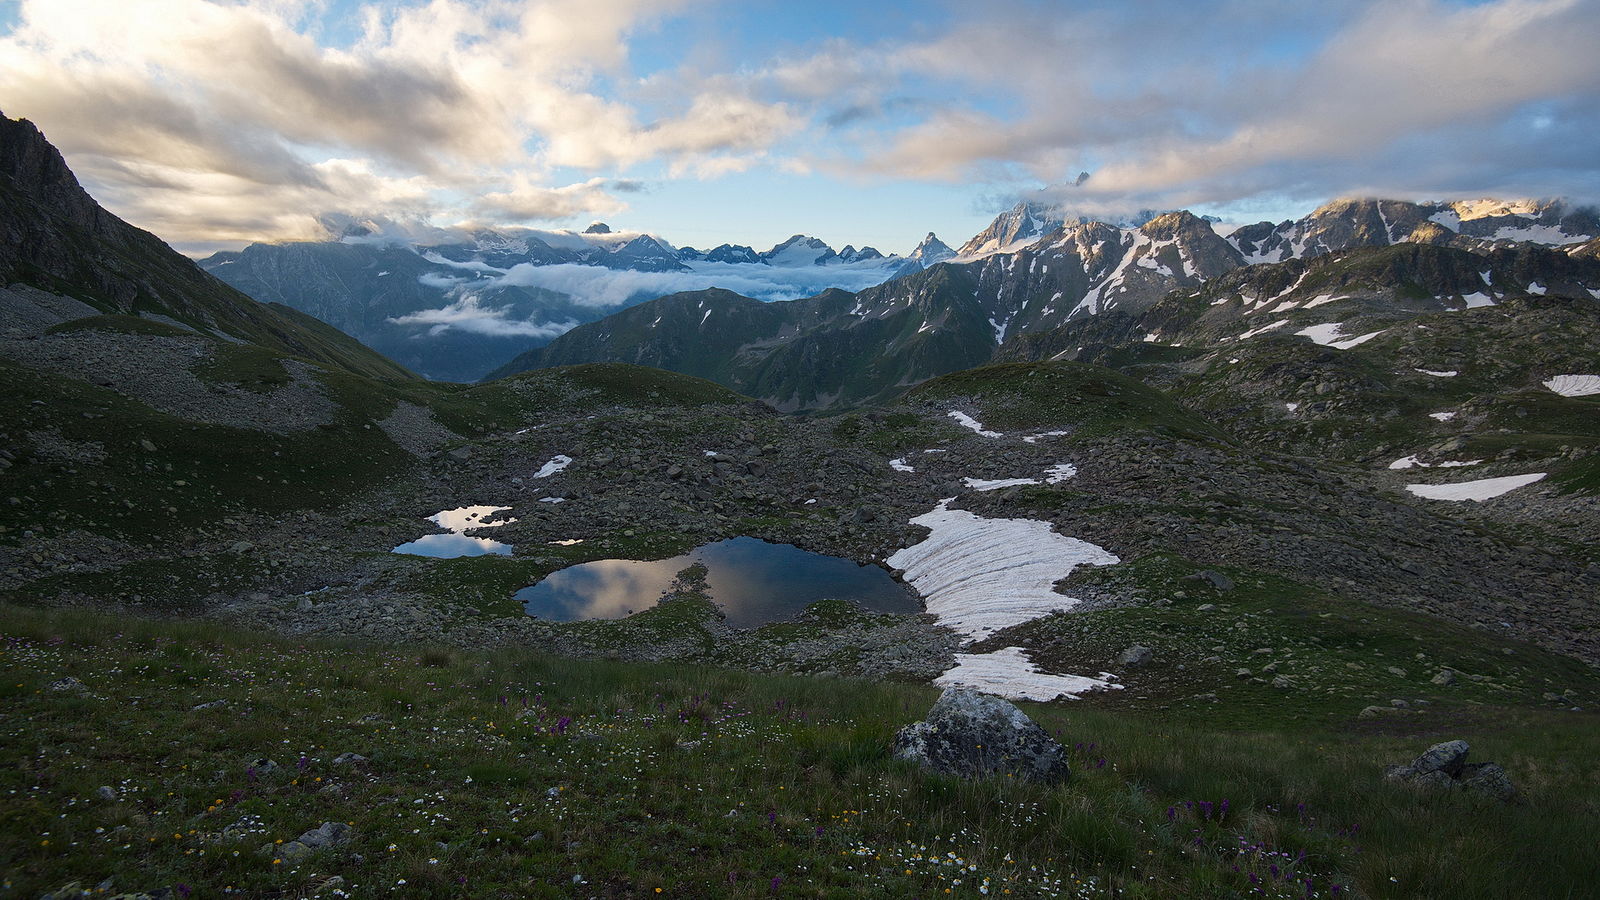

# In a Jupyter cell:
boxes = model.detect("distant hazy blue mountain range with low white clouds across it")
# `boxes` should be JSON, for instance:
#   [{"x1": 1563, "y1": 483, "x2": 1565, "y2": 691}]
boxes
[{"x1": 200, "y1": 223, "x2": 942, "y2": 381}]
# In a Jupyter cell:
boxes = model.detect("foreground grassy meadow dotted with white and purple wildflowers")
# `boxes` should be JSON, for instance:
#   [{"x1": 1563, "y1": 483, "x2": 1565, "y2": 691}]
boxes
[{"x1": 0, "y1": 607, "x2": 1600, "y2": 897}]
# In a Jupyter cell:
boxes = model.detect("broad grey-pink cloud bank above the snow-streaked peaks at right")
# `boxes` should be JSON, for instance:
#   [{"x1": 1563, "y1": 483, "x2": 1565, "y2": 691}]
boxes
[{"x1": 763, "y1": 0, "x2": 1600, "y2": 210}]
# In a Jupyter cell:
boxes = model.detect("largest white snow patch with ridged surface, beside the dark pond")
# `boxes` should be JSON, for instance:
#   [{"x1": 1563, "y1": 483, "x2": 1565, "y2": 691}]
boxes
[{"x1": 886, "y1": 498, "x2": 1122, "y2": 637}]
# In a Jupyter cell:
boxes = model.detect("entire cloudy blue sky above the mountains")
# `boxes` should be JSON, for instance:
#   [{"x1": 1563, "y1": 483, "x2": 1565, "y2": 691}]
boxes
[{"x1": 0, "y1": 0, "x2": 1600, "y2": 253}]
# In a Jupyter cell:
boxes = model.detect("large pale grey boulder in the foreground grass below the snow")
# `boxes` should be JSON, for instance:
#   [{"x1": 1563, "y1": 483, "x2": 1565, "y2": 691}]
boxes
[{"x1": 894, "y1": 687, "x2": 1070, "y2": 781}]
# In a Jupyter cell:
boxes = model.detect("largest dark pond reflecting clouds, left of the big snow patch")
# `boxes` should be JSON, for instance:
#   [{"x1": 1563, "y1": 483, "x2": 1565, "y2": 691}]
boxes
[{"x1": 517, "y1": 538, "x2": 922, "y2": 628}]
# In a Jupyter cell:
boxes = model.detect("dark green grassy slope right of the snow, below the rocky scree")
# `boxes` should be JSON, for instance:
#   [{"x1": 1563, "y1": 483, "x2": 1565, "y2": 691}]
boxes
[{"x1": 979, "y1": 554, "x2": 1600, "y2": 732}]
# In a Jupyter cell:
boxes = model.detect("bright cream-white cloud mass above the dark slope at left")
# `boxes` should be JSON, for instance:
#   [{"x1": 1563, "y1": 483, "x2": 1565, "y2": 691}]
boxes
[{"x1": 0, "y1": 0, "x2": 802, "y2": 243}]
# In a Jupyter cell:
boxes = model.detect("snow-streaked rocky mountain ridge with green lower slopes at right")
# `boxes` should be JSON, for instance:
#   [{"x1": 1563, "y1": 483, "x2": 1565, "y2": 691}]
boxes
[{"x1": 499, "y1": 200, "x2": 1600, "y2": 410}]
